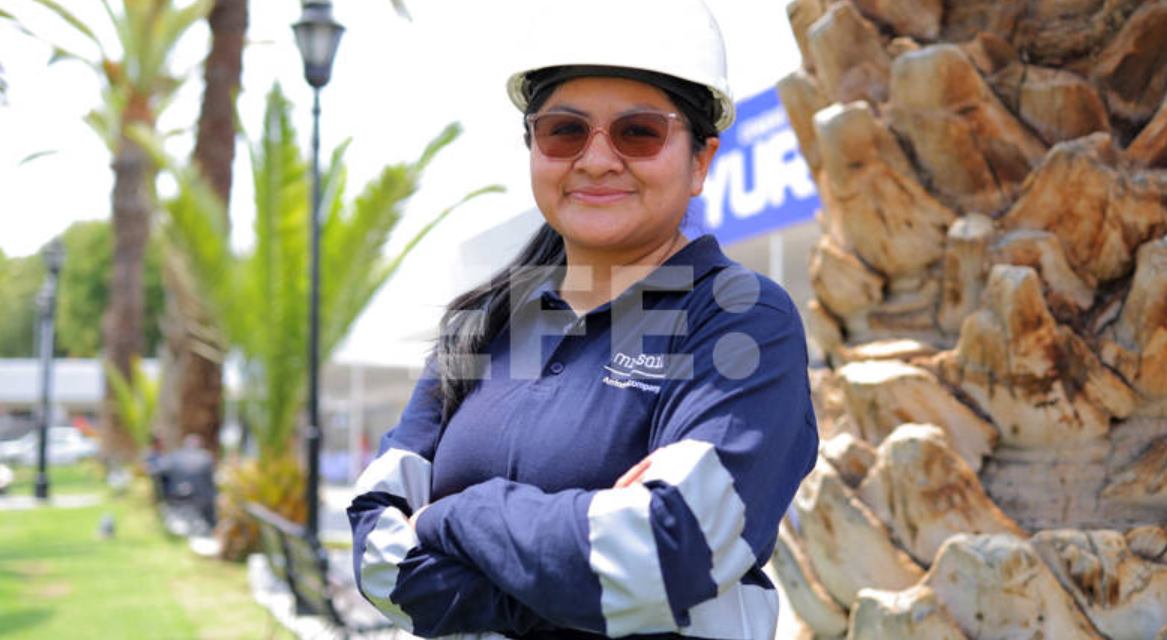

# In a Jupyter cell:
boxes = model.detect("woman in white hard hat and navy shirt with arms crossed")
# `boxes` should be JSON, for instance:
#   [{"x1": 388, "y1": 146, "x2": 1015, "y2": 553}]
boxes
[{"x1": 349, "y1": 0, "x2": 818, "y2": 639}]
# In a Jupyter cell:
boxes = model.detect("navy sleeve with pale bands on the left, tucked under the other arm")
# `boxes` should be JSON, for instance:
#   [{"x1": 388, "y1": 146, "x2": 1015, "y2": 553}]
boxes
[{"x1": 348, "y1": 362, "x2": 547, "y2": 638}]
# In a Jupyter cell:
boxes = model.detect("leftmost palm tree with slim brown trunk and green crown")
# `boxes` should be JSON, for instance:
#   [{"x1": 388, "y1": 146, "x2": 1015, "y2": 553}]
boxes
[{"x1": 0, "y1": 0, "x2": 212, "y2": 462}]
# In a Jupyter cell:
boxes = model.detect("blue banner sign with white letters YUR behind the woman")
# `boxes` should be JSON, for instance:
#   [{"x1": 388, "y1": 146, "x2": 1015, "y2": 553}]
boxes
[{"x1": 685, "y1": 89, "x2": 820, "y2": 245}]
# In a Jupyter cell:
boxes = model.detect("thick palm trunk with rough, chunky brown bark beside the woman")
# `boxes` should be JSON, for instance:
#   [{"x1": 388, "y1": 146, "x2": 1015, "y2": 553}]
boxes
[{"x1": 775, "y1": 0, "x2": 1167, "y2": 640}]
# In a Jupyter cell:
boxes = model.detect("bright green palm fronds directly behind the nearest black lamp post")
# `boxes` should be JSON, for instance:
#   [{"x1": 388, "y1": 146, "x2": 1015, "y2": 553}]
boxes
[{"x1": 167, "y1": 86, "x2": 499, "y2": 459}]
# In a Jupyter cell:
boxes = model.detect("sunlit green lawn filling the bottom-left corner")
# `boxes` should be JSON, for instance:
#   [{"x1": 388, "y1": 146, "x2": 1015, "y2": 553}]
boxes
[{"x1": 0, "y1": 467, "x2": 293, "y2": 640}]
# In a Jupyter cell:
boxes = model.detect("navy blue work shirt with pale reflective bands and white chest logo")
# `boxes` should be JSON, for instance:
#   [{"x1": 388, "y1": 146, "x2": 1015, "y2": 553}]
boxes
[{"x1": 350, "y1": 236, "x2": 818, "y2": 639}]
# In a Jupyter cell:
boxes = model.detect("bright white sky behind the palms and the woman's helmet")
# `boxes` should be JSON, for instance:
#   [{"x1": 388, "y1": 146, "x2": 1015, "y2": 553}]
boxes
[{"x1": 0, "y1": 0, "x2": 799, "y2": 363}]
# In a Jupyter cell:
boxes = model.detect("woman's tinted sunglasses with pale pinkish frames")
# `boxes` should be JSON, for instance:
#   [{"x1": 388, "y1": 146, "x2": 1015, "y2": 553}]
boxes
[{"x1": 526, "y1": 111, "x2": 679, "y2": 160}]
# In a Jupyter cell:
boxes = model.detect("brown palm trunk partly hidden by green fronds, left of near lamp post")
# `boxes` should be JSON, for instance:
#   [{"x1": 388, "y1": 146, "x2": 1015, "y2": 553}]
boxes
[{"x1": 160, "y1": 0, "x2": 247, "y2": 454}]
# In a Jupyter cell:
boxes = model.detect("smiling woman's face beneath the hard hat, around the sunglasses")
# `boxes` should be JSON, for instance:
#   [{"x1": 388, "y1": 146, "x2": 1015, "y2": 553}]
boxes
[{"x1": 531, "y1": 77, "x2": 718, "y2": 258}]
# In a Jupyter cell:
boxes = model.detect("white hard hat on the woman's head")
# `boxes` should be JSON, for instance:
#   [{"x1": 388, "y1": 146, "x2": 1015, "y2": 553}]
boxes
[{"x1": 506, "y1": 0, "x2": 734, "y2": 132}]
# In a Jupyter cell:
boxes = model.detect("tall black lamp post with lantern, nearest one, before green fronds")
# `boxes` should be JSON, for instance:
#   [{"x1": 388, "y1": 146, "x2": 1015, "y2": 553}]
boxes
[{"x1": 292, "y1": 0, "x2": 344, "y2": 537}]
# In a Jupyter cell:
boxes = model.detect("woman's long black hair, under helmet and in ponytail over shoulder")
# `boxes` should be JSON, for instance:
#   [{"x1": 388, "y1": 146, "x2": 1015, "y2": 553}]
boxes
[{"x1": 433, "y1": 67, "x2": 718, "y2": 426}]
